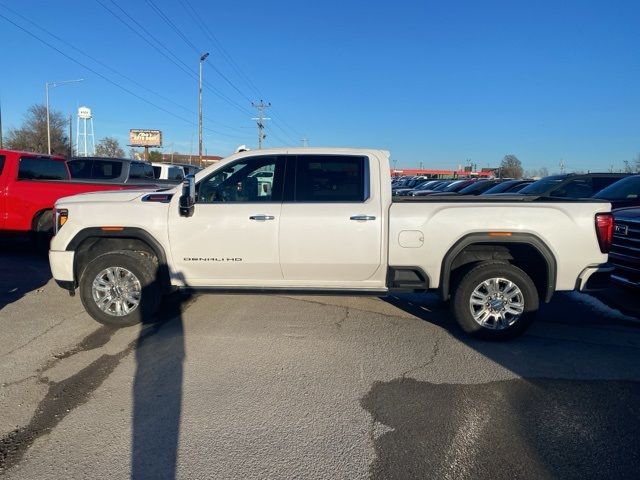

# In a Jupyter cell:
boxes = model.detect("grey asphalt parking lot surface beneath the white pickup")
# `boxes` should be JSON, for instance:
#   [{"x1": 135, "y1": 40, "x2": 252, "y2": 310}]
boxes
[{"x1": 0, "y1": 243, "x2": 640, "y2": 479}]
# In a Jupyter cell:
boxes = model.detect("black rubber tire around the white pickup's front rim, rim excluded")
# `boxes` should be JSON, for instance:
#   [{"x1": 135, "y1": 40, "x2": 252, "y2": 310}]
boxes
[{"x1": 79, "y1": 250, "x2": 160, "y2": 327}]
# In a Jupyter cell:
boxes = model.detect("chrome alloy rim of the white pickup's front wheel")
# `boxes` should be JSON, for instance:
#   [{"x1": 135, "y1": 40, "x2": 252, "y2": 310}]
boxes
[{"x1": 91, "y1": 267, "x2": 142, "y2": 317}]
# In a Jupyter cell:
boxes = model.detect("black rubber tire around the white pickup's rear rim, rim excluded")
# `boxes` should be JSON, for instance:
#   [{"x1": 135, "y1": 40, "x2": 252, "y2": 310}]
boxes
[{"x1": 451, "y1": 262, "x2": 539, "y2": 340}]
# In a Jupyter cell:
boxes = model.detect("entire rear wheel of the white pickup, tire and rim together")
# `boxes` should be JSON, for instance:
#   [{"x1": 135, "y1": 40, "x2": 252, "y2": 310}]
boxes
[{"x1": 451, "y1": 262, "x2": 538, "y2": 340}]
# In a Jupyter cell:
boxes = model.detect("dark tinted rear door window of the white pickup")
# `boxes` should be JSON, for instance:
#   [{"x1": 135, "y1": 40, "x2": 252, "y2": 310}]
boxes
[{"x1": 294, "y1": 155, "x2": 367, "y2": 202}]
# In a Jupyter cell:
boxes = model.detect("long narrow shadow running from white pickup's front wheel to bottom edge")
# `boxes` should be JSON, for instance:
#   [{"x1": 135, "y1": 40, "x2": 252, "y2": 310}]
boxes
[{"x1": 131, "y1": 266, "x2": 193, "y2": 480}]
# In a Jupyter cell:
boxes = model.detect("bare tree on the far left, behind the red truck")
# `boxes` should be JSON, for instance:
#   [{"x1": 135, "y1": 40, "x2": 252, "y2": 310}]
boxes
[{"x1": 6, "y1": 105, "x2": 70, "y2": 155}]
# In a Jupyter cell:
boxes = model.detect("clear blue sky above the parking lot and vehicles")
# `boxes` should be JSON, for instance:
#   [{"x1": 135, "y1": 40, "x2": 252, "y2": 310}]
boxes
[{"x1": 0, "y1": 0, "x2": 640, "y2": 171}]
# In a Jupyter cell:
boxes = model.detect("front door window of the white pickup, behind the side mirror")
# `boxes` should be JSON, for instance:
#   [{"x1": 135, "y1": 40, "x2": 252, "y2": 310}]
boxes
[{"x1": 197, "y1": 156, "x2": 284, "y2": 203}]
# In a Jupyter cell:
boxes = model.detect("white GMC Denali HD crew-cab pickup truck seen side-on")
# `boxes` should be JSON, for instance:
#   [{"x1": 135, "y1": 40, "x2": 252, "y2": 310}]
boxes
[{"x1": 49, "y1": 148, "x2": 613, "y2": 339}]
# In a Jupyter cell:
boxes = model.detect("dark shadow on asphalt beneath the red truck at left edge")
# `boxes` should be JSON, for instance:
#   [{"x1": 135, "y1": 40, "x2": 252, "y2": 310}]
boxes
[{"x1": 0, "y1": 238, "x2": 51, "y2": 310}]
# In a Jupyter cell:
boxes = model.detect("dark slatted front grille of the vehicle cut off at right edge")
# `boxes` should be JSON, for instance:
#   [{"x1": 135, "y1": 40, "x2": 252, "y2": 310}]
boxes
[{"x1": 609, "y1": 218, "x2": 640, "y2": 287}]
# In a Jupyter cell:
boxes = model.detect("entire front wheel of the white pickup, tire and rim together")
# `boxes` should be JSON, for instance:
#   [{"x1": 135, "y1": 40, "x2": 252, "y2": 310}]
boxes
[{"x1": 79, "y1": 250, "x2": 160, "y2": 327}]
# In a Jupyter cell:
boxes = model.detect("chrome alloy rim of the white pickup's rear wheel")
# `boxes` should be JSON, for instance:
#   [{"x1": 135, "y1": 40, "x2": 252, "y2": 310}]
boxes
[{"x1": 469, "y1": 278, "x2": 524, "y2": 330}]
